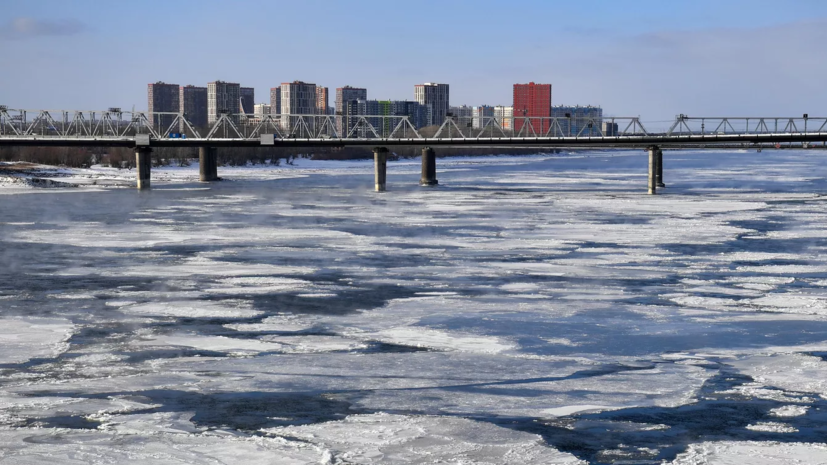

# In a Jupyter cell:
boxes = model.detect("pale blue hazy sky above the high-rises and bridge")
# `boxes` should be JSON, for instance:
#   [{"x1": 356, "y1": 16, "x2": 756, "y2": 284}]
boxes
[{"x1": 0, "y1": 0, "x2": 827, "y2": 122}]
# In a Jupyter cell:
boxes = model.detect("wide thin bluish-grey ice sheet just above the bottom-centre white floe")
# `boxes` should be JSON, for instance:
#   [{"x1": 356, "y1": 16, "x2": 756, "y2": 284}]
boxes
[{"x1": 158, "y1": 352, "x2": 714, "y2": 417}]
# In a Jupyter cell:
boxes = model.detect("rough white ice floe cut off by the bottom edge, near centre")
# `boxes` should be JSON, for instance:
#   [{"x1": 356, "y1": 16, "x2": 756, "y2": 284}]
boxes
[{"x1": 264, "y1": 413, "x2": 586, "y2": 465}]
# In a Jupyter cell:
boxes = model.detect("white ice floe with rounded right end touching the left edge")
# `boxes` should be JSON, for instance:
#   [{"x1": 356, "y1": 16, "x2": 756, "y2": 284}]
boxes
[{"x1": 0, "y1": 318, "x2": 75, "y2": 364}]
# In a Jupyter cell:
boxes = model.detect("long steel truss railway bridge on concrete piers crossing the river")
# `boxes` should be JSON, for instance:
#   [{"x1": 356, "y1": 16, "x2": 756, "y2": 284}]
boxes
[{"x1": 0, "y1": 105, "x2": 827, "y2": 194}]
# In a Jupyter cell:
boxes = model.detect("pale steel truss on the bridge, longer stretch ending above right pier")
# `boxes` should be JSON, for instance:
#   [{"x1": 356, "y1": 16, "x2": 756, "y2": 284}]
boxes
[{"x1": 0, "y1": 106, "x2": 649, "y2": 140}]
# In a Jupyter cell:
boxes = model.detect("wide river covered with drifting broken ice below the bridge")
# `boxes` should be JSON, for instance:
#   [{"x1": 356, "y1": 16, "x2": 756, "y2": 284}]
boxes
[{"x1": 0, "y1": 150, "x2": 827, "y2": 464}]
